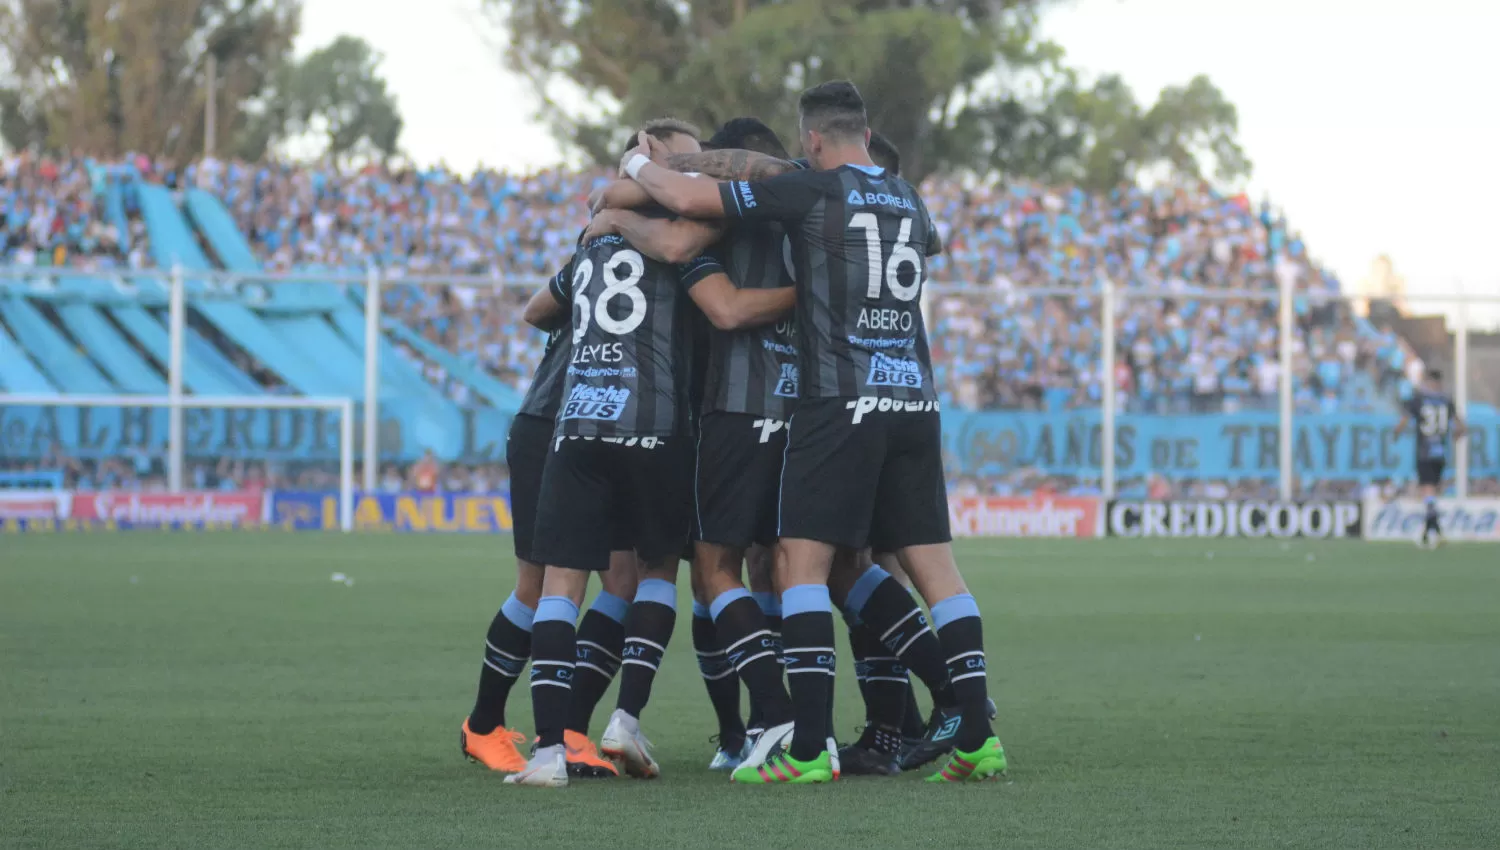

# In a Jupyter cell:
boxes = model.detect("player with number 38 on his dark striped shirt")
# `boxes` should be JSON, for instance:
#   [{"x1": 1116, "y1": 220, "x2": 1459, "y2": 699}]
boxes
[{"x1": 506, "y1": 126, "x2": 717, "y2": 787}]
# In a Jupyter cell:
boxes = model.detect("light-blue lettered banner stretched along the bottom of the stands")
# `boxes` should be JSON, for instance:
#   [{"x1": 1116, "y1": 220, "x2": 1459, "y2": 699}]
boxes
[{"x1": 0, "y1": 405, "x2": 1500, "y2": 481}]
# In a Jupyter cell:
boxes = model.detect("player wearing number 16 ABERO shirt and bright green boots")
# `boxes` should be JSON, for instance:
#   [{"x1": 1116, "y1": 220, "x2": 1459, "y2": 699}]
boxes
[{"x1": 621, "y1": 81, "x2": 1005, "y2": 784}]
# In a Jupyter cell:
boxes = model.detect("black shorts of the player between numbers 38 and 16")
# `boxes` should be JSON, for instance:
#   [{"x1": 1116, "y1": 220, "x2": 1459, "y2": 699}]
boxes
[{"x1": 693, "y1": 412, "x2": 786, "y2": 549}]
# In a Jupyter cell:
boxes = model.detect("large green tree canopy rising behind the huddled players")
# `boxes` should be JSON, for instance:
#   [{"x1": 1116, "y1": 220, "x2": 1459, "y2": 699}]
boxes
[{"x1": 485, "y1": 0, "x2": 1250, "y2": 187}]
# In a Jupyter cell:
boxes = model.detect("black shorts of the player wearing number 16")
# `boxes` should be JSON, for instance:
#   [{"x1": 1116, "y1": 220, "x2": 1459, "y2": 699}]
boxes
[{"x1": 779, "y1": 399, "x2": 953, "y2": 552}]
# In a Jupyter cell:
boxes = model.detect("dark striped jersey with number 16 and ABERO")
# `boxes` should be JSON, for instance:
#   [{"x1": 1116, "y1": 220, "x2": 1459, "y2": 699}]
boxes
[{"x1": 719, "y1": 165, "x2": 941, "y2": 402}]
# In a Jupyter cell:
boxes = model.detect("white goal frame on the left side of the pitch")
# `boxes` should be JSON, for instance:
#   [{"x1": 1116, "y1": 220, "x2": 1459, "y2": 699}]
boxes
[{"x1": 0, "y1": 393, "x2": 354, "y2": 532}]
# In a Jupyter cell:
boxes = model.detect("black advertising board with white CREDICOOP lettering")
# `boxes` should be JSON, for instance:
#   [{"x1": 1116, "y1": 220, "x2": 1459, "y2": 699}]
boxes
[{"x1": 1109, "y1": 499, "x2": 1361, "y2": 538}]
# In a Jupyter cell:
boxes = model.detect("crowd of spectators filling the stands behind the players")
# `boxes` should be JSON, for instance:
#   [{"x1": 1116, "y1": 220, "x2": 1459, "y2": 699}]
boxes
[{"x1": 0, "y1": 153, "x2": 1452, "y2": 489}]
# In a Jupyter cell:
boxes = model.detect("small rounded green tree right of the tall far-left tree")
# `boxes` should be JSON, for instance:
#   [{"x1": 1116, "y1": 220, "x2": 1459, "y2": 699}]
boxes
[{"x1": 267, "y1": 36, "x2": 402, "y2": 156}]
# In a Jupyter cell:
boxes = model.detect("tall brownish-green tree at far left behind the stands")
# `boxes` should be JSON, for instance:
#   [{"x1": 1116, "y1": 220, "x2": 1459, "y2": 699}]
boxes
[{"x1": 0, "y1": 0, "x2": 302, "y2": 159}]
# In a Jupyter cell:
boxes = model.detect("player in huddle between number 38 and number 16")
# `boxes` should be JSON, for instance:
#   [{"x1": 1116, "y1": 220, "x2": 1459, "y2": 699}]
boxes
[{"x1": 590, "y1": 118, "x2": 797, "y2": 769}]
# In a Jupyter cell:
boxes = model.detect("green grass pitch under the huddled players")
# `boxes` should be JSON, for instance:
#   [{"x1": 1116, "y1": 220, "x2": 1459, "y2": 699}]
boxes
[{"x1": 0, "y1": 532, "x2": 1500, "y2": 850}]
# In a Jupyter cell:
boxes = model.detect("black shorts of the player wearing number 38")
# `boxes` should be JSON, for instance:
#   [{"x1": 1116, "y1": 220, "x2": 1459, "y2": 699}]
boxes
[{"x1": 533, "y1": 436, "x2": 693, "y2": 573}]
